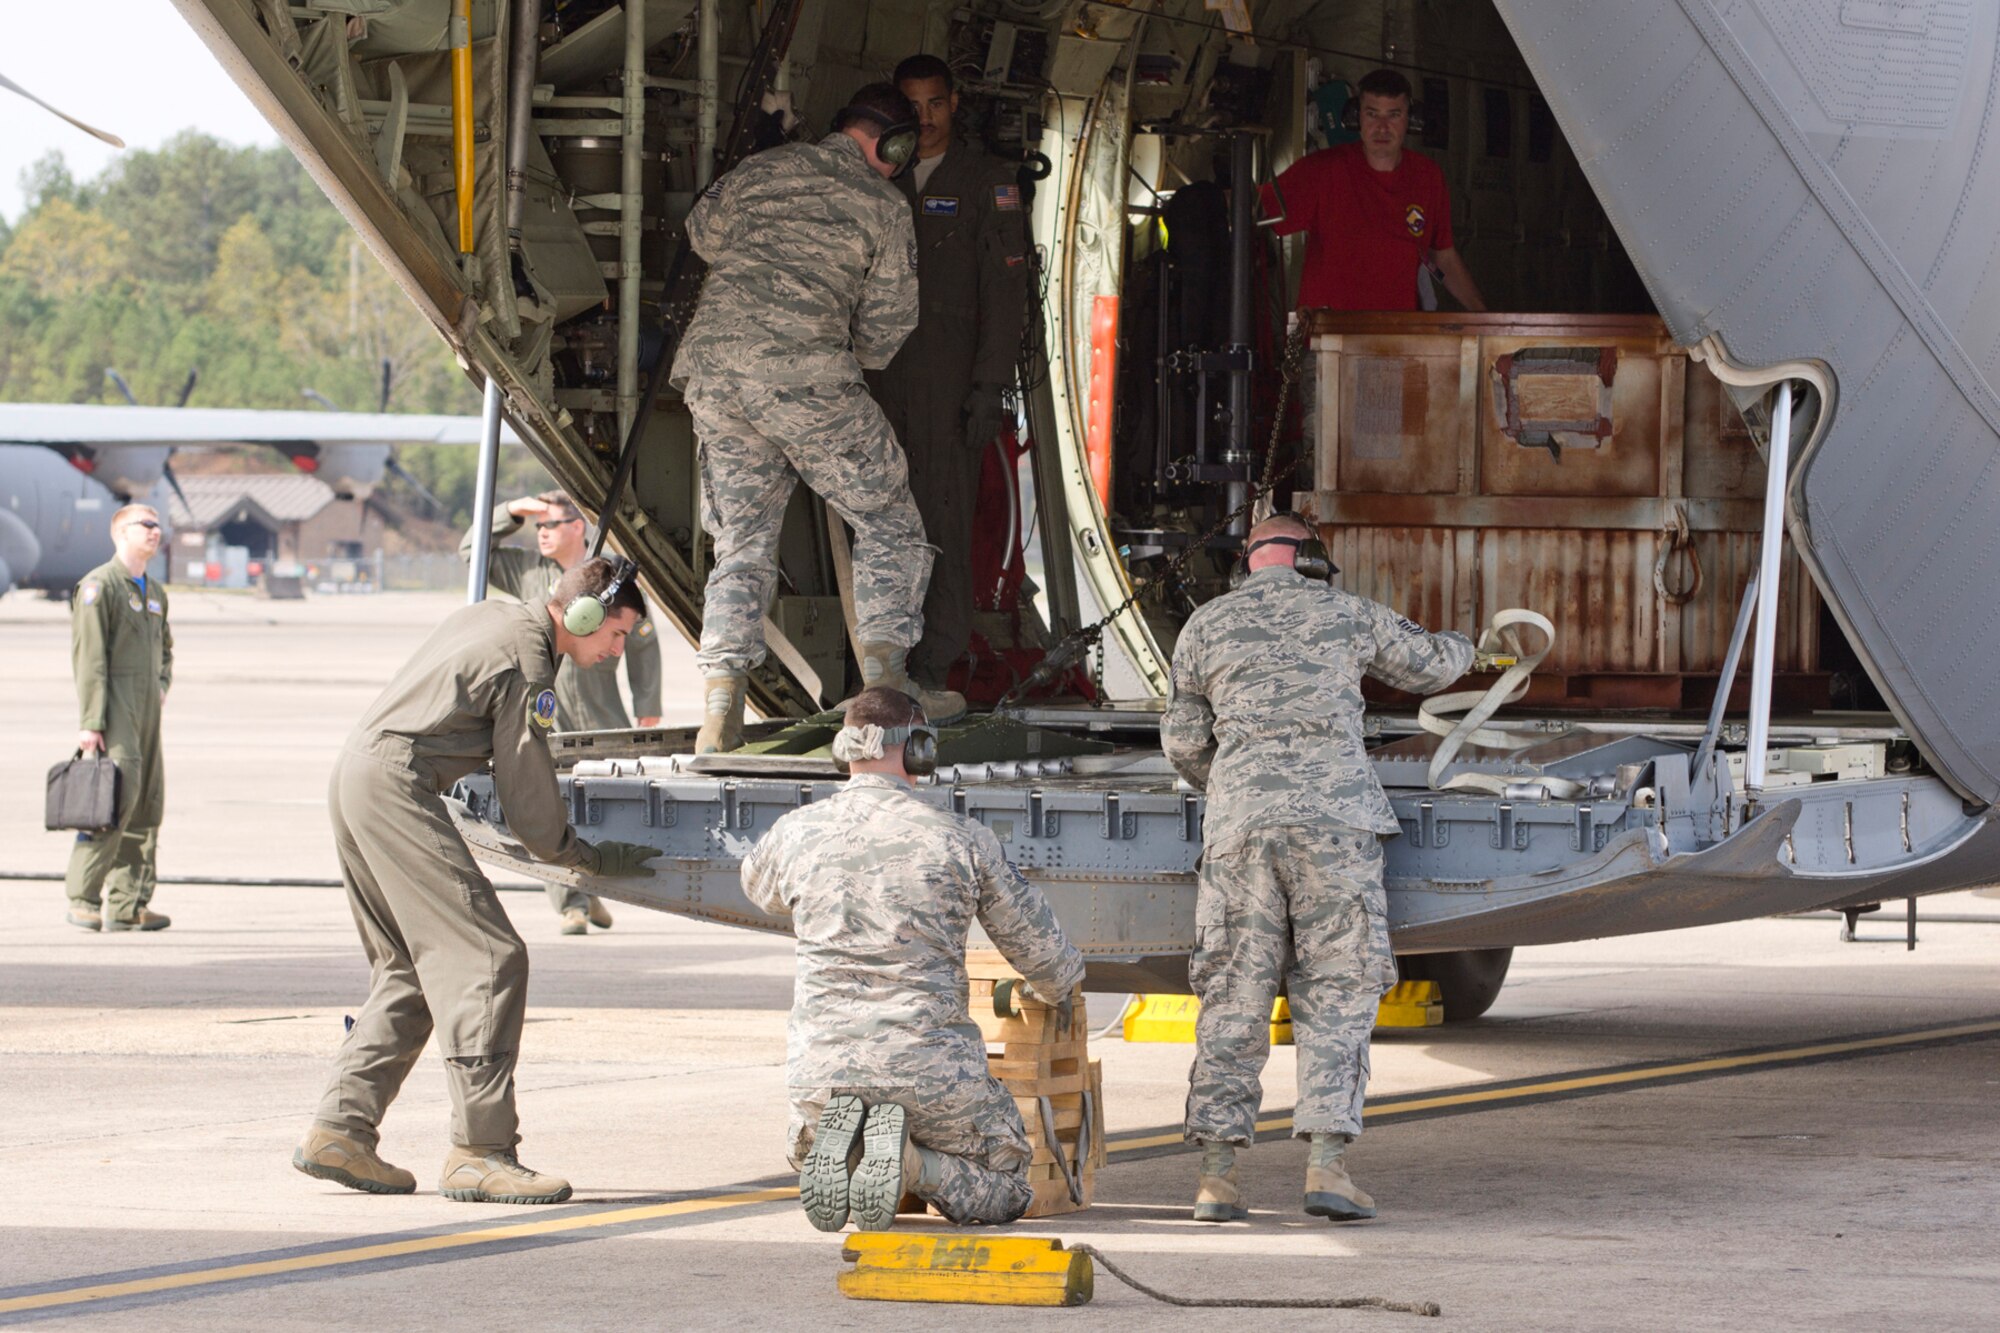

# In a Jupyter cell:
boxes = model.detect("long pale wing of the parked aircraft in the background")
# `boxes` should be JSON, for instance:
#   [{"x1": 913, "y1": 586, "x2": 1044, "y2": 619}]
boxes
[{"x1": 0, "y1": 402, "x2": 520, "y2": 444}]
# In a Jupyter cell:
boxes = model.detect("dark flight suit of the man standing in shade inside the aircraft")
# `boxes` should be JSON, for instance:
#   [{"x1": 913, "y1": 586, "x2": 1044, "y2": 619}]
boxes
[{"x1": 870, "y1": 144, "x2": 1028, "y2": 687}]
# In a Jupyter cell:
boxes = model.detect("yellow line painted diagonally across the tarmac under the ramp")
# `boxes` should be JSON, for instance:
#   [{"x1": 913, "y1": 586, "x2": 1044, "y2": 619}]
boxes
[{"x1": 0, "y1": 1021, "x2": 2000, "y2": 1315}]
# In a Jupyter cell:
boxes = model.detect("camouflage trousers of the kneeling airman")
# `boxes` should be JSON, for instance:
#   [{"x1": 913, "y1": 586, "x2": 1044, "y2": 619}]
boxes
[{"x1": 786, "y1": 1075, "x2": 1034, "y2": 1227}]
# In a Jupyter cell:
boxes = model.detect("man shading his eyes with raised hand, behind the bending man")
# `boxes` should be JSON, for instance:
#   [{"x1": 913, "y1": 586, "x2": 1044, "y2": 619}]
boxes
[{"x1": 458, "y1": 490, "x2": 660, "y2": 935}]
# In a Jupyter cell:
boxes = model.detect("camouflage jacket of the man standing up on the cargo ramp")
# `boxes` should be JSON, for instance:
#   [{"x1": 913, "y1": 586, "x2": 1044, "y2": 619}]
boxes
[{"x1": 672, "y1": 134, "x2": 916, "y2": 388}]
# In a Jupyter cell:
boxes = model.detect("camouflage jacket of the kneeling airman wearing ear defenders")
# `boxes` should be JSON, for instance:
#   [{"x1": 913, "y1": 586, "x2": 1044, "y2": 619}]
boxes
[{"x1": 742, "y1": 773, "x2": 1084, "y2": 1089}]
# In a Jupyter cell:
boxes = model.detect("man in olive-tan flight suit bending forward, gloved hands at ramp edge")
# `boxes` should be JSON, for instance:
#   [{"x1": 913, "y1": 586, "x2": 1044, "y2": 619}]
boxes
[{"x1": 292, "y1": 560, "x2": 658, "y2": 1203}]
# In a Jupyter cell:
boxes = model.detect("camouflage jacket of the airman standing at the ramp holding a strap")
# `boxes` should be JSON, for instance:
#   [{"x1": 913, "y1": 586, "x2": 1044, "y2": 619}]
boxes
[{"x1": 1160, "y1": 564, "x2": 1472, "y2": 853}]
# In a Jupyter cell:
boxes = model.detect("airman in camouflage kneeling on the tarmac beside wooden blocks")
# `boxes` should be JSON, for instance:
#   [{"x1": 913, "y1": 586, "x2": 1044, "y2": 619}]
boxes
[{"x1": 742, "y1": 689, "x2": 1084, "y2": 1231}]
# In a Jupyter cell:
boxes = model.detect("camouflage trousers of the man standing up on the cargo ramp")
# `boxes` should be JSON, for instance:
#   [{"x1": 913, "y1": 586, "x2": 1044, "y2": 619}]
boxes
[{"x1": 686, "y1": 376, "x2": 936, "y2": 677}]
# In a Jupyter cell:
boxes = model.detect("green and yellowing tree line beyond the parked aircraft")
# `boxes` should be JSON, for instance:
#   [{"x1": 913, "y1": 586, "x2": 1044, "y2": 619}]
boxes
[{"x1": 0, "y1": 130, "x2": 540, "y2": 522}]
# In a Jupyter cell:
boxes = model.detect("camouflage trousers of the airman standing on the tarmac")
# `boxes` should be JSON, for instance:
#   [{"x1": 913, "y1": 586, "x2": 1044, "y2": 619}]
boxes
[{"x1": 1186, "y1": 825, "x2": 1396, "y2": 1143}]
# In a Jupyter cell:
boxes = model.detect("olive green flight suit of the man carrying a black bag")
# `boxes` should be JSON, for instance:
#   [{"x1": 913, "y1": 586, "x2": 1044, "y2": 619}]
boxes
[{"x1": 64, "y1": 558, "x2": 174, "y2": 921}]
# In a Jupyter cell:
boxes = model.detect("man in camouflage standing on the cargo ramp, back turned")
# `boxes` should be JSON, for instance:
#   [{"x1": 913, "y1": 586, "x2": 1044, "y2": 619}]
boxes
[{"x1": 672, "y1": 84, "x2": 964, "y2": 753}]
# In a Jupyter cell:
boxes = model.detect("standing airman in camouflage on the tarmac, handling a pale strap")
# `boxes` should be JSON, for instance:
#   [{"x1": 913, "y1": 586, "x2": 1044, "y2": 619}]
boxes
[{"x1": 1160, "y1": 516, "x2": 1472, "y2": 1221}]
